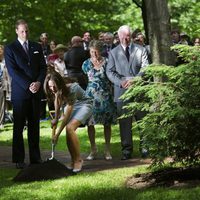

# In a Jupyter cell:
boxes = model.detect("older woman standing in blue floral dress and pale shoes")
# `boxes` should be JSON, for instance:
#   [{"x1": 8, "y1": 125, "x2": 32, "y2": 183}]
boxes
[{"x1": 82, "y1": 40, "x2": 116, "y2": 160}]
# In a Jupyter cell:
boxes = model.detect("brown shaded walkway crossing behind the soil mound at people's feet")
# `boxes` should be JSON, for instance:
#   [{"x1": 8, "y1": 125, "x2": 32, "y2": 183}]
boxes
[{"x1": 0, "y1": 146, "x2": 150, "y2": 171}]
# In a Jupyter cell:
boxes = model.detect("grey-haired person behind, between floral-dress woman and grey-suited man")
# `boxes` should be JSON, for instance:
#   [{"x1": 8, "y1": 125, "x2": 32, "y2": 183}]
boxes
[{"x1": 102, "y1": 32, "x2": 115, "y2": 58}]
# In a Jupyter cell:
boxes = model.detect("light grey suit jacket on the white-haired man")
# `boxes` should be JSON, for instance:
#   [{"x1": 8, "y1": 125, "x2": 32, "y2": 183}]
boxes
[{"x1": 106, "y1": 44, "x2": 149, "y2": 102}]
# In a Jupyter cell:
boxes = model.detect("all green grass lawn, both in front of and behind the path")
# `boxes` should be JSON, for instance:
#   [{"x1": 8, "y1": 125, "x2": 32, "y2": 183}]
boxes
[{"x1": 0, "y1": 122, "x2": 200, "y2": 200}]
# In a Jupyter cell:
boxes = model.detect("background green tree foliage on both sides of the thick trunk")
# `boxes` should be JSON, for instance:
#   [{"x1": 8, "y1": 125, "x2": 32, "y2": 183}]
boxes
[{"x1": 0, "y1": 0, "x2": 200, "y2": 43}]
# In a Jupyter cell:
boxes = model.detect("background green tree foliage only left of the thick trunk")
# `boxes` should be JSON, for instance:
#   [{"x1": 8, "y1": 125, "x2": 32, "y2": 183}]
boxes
[{"x1": 0, "y1": 0, "x2": 141, "y2": 43}]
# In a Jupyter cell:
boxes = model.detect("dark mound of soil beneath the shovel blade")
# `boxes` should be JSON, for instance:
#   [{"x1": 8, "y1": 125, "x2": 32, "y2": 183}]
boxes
[{"x1": 13, "y1": 159, "x2": 74, "y2": 182}]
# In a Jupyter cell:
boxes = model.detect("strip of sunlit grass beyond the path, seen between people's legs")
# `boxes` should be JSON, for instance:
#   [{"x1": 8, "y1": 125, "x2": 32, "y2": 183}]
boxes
[{"x1": 0, "y1": 121, "x2": 139, "y2": 157}]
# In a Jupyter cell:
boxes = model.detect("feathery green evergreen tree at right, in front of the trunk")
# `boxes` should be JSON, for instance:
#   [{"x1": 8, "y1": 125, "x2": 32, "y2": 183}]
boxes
[{"x1": 123, "y1": 45, "x2": 200, "y2": 166}]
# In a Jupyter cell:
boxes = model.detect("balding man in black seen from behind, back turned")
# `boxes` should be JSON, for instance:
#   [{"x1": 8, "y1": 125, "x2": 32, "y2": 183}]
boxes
[{"x1": 64, "y1": 36, "x2": 88, "y2": 90}]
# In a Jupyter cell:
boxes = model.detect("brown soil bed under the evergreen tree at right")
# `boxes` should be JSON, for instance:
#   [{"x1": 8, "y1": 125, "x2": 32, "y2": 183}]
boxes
[{"x1": 126, "y1": 167, "x2": 200, "y2": 189}]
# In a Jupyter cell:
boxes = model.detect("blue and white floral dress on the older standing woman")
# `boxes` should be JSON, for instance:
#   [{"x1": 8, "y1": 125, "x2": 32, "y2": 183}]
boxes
[{"x1": 82, "y1": 59, "x2": 116, "y2": 125}]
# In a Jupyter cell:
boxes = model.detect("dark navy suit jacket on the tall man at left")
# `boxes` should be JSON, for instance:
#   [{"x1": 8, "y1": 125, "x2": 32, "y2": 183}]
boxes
[{"x1": 5, "y1": 40, "x2": 46, "y2": 100}]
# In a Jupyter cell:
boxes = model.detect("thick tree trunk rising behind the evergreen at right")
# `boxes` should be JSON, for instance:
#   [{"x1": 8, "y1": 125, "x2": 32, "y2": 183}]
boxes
[{"x1": 142, "y1": 0, "x2": 175, "y2": 65}]
